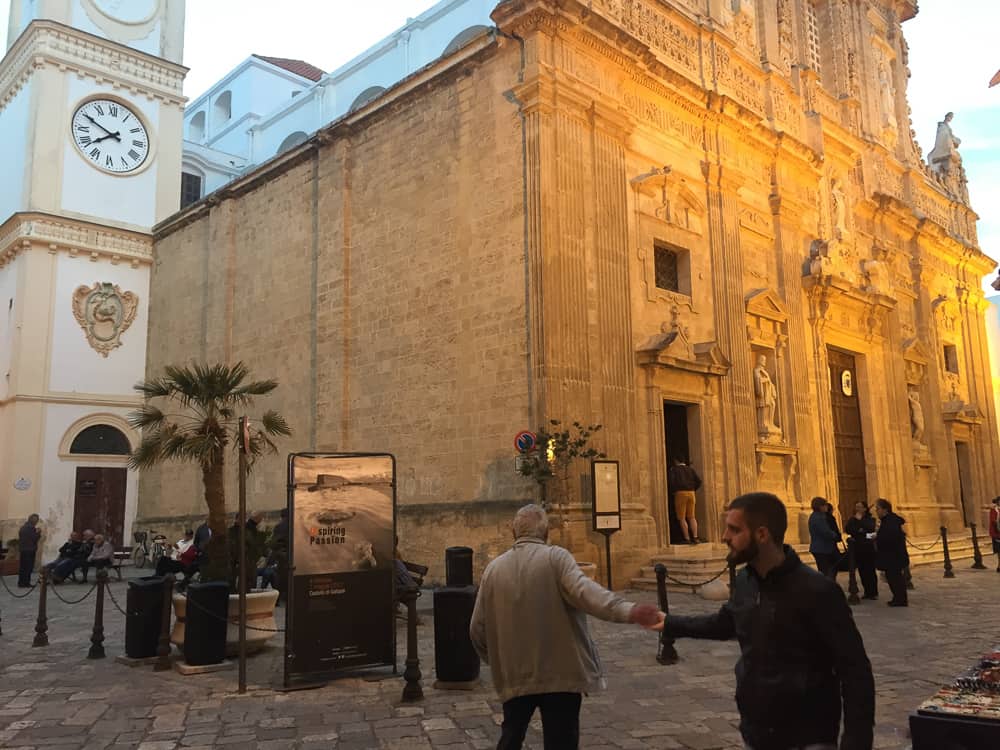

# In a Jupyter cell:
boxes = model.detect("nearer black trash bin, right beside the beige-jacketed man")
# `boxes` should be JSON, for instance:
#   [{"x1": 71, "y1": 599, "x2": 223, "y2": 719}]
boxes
[{"x1": 434, "y1": 588, "x2": 479, "y2": 682}]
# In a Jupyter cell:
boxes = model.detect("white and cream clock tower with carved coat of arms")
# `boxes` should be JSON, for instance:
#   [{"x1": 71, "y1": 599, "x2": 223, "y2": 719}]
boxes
[{"x1": 0, "y1": 0, "x2": 187, "y2": 556}]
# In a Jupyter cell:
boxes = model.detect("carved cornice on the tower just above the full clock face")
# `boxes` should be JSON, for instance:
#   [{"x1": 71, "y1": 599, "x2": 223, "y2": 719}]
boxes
[{"x1": 0, "y1": 21, "x2": 188, "y2": 109}]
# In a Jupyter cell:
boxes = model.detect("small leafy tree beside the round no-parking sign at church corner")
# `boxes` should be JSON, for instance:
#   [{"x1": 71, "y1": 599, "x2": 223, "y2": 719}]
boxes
[{"x1": 519, "y1": 419, "x2": 607, "y2": 528}]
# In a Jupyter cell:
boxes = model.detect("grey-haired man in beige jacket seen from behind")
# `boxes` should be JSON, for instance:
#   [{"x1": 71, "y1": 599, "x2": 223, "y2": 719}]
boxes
[{"x1": 469, "y1": 505, "x2": 659, "y2": 750}]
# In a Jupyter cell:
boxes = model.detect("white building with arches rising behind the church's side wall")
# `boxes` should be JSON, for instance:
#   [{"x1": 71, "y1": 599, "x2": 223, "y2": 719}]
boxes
[{"x1": 182, "y1": 0, "x2": 498, "y2": 205}]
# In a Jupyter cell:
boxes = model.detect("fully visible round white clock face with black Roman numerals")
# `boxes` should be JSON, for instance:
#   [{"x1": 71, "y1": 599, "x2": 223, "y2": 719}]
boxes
[{"x1": 72, "y1": 99, "x2": 149, "y2": 173}]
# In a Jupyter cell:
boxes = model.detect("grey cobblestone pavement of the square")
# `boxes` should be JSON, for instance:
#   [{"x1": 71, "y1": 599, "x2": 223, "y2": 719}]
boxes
[{"x1": 0, "y1": 558, "x2": 1000, "y2": 750}]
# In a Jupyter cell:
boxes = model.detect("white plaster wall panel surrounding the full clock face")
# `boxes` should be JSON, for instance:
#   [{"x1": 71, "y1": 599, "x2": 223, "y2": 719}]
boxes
[{"x1": 61, "y1": 76, "x2": 160, "y2": 230}]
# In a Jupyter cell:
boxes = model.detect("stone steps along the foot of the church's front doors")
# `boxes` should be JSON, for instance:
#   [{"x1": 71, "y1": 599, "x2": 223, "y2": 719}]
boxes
[{"x1": 630, "y1": 532, "x2": 995, "y2": 593}]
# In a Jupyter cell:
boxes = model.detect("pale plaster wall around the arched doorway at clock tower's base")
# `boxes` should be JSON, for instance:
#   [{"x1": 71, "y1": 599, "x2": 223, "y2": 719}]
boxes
[{"x1": 37, "y1": 404, "x2": 139, "y2": 562}]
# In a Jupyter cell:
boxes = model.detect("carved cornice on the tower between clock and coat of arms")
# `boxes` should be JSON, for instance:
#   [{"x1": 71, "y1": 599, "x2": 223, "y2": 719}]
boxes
[{"x1": 0, "y1": 213, "x2": 153, "y2": 268}]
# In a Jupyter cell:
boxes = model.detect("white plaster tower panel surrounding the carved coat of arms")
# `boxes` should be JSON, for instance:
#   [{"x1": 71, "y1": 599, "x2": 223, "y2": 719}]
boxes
[{"x1": 49, "y1": 254, "x2": 149, "y2": 397}]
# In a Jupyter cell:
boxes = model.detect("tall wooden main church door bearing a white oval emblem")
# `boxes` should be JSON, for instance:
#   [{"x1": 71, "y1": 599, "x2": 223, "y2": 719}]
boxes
[{"x1": 827, "y1": 349, "x2": 868, "y2": 519}]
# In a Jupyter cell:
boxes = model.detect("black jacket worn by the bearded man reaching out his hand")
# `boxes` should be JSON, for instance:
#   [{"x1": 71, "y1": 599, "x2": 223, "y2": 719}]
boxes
[{"x1": 666, "y1": 548, "x2": 875, "y2": 750}]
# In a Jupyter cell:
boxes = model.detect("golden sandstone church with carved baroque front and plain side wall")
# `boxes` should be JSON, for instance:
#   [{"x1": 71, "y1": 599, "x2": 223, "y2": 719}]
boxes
[{"x1": 139, "y1": 0, "x2": 1000, "y2": 580}]
